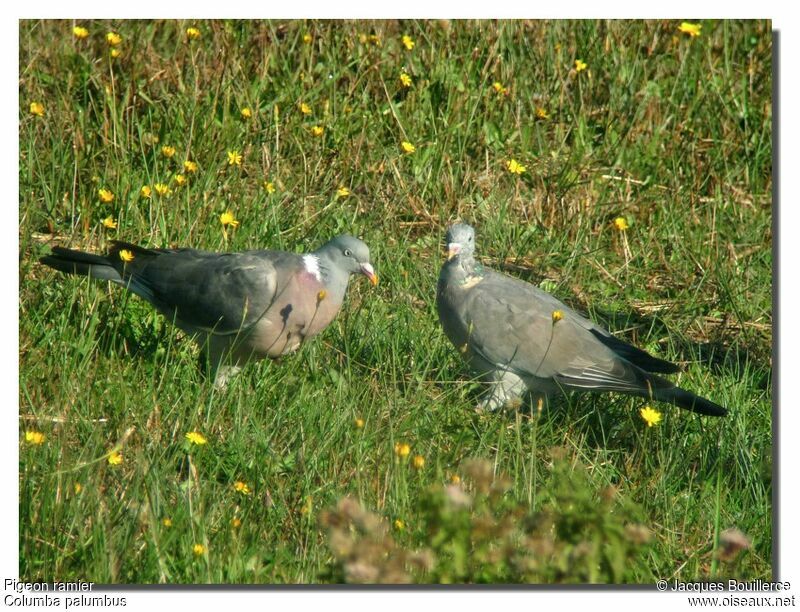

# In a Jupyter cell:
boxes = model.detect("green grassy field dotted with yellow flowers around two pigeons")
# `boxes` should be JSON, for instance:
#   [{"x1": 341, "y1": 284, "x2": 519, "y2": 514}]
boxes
[{"x1": 19, "y1": 21, "x2": 773, "y2": 584}]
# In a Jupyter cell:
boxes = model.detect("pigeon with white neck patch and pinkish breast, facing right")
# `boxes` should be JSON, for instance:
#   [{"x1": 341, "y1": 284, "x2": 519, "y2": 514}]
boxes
[{"x1": 40, "y1": 235, "x2": 378, "y2": 387}]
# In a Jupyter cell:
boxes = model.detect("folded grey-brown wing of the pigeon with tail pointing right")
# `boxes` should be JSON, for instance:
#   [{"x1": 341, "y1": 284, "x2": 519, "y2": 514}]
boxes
[{"x1": 464, "y1": 275, "x2": 645, "y2": 391}]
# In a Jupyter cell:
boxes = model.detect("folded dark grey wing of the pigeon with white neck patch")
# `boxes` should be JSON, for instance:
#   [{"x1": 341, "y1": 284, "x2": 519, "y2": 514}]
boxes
[{"x1": 123, "y1": 249, "x2": 292, "y2": 334}]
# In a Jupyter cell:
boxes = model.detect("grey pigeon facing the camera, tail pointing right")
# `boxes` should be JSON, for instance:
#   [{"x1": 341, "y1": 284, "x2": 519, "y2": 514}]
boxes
[{"x1": 436, "y1": 224, "x2": 727, "y2": 416}]
